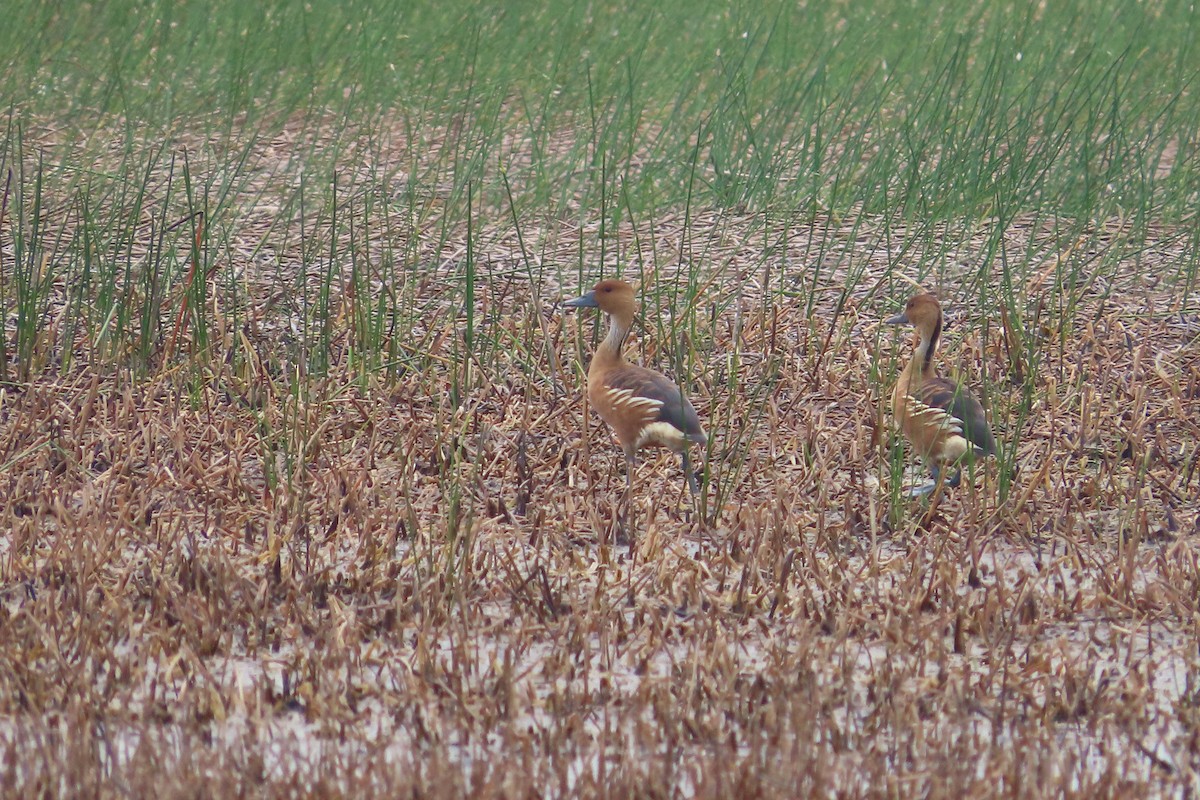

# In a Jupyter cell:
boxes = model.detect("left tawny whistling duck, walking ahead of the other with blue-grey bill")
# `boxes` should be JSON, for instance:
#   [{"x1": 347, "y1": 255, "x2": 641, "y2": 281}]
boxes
[{"x1": 563, "y1": 279, "x2": 708, "y2": 493}]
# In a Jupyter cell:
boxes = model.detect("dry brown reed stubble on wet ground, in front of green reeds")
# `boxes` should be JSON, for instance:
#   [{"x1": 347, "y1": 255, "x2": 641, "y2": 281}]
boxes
[{"x1": 0, "y1": 128, "x2": 1200, "y2": 798}]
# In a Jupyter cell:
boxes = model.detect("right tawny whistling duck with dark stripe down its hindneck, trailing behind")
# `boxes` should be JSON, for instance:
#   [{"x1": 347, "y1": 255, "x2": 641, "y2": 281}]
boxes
[{"x1": 884, "y1": 294, "x2": 996, "y2": 495}]
